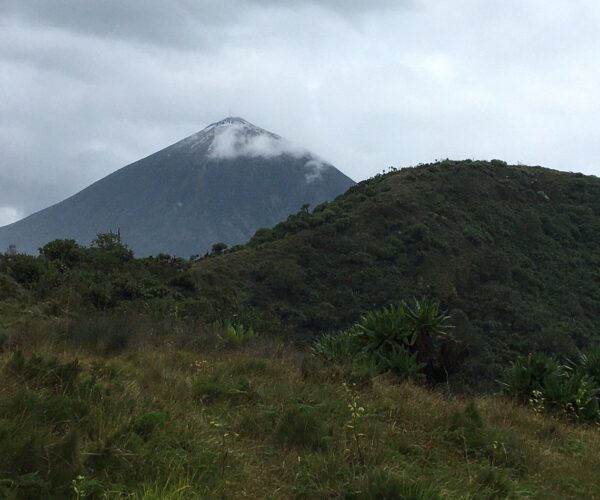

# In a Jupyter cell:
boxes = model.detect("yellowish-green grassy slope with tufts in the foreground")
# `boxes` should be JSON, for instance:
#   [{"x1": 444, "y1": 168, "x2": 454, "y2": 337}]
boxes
[{"x1": 0, "y1": 338, "x2": 600, "y2": 499}]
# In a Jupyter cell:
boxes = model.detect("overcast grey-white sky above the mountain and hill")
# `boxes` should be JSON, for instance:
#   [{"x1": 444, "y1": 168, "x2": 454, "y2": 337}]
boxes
[{"x1": 0, "y1": 0, "x2": 600, "y2": 225}]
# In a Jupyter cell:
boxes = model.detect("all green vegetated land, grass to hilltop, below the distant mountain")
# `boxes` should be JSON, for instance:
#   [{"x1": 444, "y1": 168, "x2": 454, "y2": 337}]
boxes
[{"x1": 0, "y1": 161, "x2": 600, "y2": 499}]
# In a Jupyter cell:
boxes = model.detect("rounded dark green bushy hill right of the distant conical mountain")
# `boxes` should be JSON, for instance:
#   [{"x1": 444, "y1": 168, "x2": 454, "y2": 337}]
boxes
[{"x1": 194, "y1": 160, "x2": 600, "y2": 379}]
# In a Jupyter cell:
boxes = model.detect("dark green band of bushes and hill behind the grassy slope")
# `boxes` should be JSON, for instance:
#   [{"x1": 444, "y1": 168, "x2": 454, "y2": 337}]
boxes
[{"x1": 0, "y1": 161, "x2": 600, "y2": 388}]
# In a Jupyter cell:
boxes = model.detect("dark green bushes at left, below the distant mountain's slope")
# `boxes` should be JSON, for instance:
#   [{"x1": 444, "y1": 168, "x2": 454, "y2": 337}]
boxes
[{"x1": 0, "y1": 233, "x2": 204, "y2": 316}]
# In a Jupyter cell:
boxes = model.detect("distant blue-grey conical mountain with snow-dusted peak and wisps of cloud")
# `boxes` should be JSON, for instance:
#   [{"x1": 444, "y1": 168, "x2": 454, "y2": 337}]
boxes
[{"x1": 0, "y1": 117, "x2": 354, "y2": 257}]
